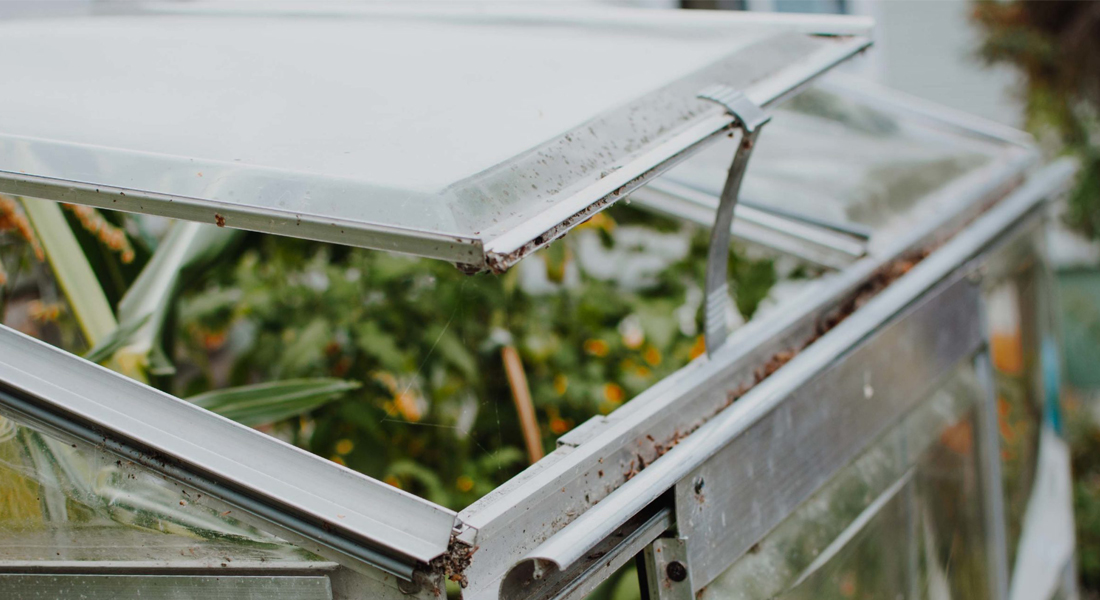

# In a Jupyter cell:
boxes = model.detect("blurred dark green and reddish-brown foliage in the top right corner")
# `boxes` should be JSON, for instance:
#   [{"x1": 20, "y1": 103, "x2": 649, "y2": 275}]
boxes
[{"x1": 974, "y1": 0, "x2": 1100, "y2": 238}]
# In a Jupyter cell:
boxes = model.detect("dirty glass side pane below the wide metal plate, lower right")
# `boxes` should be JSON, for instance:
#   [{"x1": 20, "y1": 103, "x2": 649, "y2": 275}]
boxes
[{"x1": 701, "y1": 363, "x2": 988, "y2": 600}]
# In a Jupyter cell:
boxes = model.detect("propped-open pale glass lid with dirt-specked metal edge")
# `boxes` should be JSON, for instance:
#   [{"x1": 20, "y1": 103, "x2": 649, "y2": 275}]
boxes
[{"x1": 0, "y1": 3, "x2": 868, "y2": 271}]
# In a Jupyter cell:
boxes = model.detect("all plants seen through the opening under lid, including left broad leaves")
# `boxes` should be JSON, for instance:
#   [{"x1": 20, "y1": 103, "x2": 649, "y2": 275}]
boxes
[{"x1": 0, "y1": 191, "x2": 777, "y2": 508}]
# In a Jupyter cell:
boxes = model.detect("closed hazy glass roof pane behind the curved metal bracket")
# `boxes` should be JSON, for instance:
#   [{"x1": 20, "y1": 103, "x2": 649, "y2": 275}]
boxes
[{"x1": 646, "y1": 88, "x2": 1005, "y2": 228}]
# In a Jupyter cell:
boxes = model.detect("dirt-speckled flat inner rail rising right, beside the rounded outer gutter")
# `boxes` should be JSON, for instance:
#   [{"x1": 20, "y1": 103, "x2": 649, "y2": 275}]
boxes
[{"x1": 459, "y1": 151, "x2": 1074, "y2": 598}]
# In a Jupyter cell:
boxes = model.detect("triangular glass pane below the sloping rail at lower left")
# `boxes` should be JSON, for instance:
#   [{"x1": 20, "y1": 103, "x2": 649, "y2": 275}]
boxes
[{"x1": 0, "y1": 409, "x2": 320, "y2": 567}]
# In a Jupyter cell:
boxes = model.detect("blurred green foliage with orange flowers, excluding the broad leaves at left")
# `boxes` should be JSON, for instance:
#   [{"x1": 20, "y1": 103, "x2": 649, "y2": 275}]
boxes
[{"x1": 174, "y1": 208, "x2": 776, "y2": 508}]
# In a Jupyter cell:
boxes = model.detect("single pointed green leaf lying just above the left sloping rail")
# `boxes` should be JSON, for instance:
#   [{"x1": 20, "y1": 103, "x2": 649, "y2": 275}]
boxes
[{"x1": 187, "y1": 379, "x2": 360, "y2": 427}]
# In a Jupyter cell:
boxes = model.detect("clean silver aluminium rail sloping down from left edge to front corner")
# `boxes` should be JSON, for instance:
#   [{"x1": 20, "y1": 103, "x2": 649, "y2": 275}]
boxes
[{"x1": 0, "y1": 327, "x2": 455, "y2": 580}]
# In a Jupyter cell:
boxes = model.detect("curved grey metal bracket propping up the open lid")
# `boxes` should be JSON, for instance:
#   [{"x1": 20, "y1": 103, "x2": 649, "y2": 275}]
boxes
[{"x1": 699, "y1": 86, "x2": 771, "y2": 356}]
